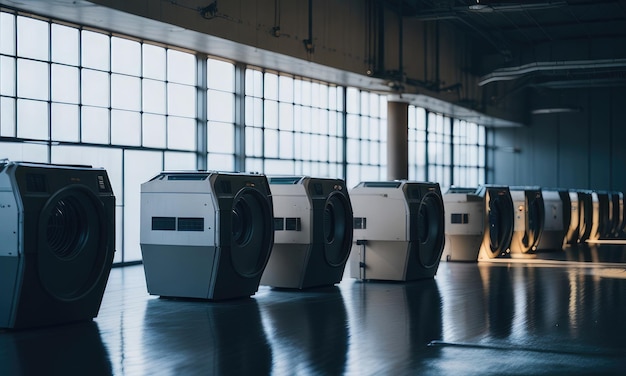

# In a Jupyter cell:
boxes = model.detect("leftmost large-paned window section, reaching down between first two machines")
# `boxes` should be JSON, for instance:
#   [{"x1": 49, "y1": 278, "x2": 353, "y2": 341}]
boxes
[{"x1": 0, "y1": 12, "x2": 196, "y2": 262}]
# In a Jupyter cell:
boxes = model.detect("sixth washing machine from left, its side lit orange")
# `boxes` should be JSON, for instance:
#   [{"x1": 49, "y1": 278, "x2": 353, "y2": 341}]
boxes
[{"x1": 509, "y1": 187, "x2": 545, "y2": 257}]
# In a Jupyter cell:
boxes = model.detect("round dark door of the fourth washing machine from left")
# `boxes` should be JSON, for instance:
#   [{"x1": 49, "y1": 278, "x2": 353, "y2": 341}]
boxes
[{"x1": 411, "y1": 192, "x2": 445, "y2": 268}]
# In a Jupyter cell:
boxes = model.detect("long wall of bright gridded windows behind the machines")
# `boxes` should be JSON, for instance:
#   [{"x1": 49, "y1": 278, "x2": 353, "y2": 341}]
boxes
[{"x1": 0, "y1": 11, "x2": 485, "y2": 263}]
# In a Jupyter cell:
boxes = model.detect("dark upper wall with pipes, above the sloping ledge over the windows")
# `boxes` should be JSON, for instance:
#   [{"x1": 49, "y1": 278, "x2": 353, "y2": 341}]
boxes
[{"x1": 92, "y1": 0, "x2": 482, "y2": 106}]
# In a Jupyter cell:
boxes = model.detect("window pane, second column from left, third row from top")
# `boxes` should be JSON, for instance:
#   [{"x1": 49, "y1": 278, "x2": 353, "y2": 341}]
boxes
[{"x1": 17, "y1": 99, "x2": 48, "y2": 140}]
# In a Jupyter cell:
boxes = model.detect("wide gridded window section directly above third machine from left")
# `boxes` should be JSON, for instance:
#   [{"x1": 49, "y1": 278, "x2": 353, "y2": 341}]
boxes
[{"x1": 245, "y1": 68, "x2": 344, "y2": 177}]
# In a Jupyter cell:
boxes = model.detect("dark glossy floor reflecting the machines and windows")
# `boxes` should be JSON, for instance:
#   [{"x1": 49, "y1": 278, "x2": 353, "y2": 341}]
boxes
[{"x1": 0, "y1": 244, "x2": 626, "y2": 376}]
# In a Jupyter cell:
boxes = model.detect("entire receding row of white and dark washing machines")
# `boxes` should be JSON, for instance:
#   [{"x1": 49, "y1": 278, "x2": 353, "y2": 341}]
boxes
[{"x1": 0, "y1": 160, "x2": 626, "y2": 328}]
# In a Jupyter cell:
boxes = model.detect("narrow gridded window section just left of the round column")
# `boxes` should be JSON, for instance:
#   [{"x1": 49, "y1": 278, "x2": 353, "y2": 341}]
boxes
[{"x1": 346, "y1": 88, "x2": 387, "y2": 187}]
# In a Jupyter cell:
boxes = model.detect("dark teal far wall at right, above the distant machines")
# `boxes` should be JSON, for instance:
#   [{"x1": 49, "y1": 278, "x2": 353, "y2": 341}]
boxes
[{"x1": 487, "y1": 87, "x2": 626, "y2": 191}]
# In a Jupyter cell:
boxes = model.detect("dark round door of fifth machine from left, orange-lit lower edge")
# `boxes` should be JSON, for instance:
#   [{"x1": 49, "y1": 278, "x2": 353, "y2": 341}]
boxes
[{"x1": 486, "y1": 194, "x2": 513, "y2": 258}]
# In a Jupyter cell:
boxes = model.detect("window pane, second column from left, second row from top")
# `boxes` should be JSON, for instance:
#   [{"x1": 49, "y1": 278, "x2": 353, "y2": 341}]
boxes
[{"x1": 17, "y1": 59, "x2": 50, "y2": 100}]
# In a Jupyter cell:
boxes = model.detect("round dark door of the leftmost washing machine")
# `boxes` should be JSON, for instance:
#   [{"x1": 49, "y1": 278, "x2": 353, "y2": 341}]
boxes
[{"x1": 37, "y1": 185, "x2": 115, "y2": 301}]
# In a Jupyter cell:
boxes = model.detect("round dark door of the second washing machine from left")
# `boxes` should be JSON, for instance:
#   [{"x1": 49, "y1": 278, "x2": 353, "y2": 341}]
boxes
[{"x1": 230, "y1": 187, "x2": 274, "y2": 278}]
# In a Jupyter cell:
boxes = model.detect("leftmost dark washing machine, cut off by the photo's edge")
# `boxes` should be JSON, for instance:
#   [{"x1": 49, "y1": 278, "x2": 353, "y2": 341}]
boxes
[{"x1": 0, "y1": 160, "x2": 115, "y2": 328}]
